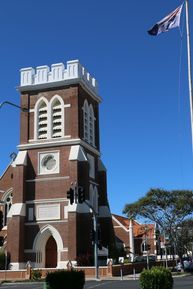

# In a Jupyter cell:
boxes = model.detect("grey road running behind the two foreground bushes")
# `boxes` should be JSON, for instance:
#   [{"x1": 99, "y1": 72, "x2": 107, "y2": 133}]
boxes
[{"x1": 0, "y1": 276, "x2": 193, "y2": 289}]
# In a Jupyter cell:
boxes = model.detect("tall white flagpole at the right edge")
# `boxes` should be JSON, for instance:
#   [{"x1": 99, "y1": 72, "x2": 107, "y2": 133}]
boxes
[{"x1": 186, "y1": 0, "x2": 193, "y2": 151}]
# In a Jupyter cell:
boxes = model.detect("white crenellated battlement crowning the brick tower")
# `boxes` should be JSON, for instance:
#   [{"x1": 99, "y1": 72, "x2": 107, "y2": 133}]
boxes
[{"x1": 20, "y1": 60, "x2": 98, "y2": 94}]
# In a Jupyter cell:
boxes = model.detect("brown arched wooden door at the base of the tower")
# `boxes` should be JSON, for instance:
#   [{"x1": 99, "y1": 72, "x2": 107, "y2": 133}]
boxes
[{"x1": 45, "y1": 236, "x2": 57, "y2": 268}]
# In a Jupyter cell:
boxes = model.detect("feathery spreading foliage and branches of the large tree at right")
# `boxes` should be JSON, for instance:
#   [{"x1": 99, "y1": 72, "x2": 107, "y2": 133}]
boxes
[{"x1": 123, "y1": 189, "x2": 193, "y2": 257}]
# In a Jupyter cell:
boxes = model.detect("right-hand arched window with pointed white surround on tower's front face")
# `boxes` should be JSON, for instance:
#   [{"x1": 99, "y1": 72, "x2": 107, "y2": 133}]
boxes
[{"x1": 51, "y1": 96, "x2": 64, "y2": 138}]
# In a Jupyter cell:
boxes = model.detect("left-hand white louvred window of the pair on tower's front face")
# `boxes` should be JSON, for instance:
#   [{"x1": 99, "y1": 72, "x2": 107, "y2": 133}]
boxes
[{"x1": 37, "y1": 102, "x2": 48, "y2": 139}]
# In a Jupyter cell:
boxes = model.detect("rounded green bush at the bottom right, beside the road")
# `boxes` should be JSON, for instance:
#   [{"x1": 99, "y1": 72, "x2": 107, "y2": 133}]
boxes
[{"x1": 140, "y1": 267, "x2": 173, "y2": 289}]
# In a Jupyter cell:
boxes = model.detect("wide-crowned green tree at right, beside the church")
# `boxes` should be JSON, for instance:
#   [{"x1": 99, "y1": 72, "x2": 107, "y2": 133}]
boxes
[{"x1": 123, "y1": 189, "x2": 193, "y2": 256}]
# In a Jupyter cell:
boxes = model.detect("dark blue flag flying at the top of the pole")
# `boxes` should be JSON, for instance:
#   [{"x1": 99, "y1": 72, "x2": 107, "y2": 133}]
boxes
[{"x1": 148, "y1": 4, "x2": 183, "y2": 36}]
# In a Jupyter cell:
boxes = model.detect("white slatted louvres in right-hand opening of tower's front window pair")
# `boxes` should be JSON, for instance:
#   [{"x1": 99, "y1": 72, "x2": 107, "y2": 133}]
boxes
[{"x1": 52, "y1": 100, "x2": 62, "y2": 138}]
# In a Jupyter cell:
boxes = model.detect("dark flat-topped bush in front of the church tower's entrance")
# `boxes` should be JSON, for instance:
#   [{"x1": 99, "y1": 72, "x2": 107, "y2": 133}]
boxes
[{"x1": 46, "y1": 270, "x2": 85, "y2": 289}]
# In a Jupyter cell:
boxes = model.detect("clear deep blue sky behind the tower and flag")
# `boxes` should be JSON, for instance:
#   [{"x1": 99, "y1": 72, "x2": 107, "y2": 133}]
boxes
[{"x1": 0, "y1": 0, "x2": 193, "y2": 214}]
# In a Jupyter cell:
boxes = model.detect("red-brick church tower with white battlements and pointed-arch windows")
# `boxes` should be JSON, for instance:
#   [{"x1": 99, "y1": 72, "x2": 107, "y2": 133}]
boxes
[{"x1": 0, "y1": 60, "x2": 114, "y2": 269}]
